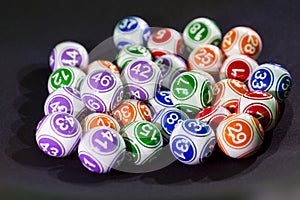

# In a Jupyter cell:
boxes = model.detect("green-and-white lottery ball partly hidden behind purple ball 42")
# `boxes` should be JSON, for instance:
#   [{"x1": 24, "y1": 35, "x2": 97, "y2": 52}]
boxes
[{"x1": 115, "y1": 45, "x2": 152, "y2": 71}]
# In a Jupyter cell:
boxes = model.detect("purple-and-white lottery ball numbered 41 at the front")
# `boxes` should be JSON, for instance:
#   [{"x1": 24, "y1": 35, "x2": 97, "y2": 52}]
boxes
[{"x1": 78, "y1": 127, "x2": 126, "y2": 174}]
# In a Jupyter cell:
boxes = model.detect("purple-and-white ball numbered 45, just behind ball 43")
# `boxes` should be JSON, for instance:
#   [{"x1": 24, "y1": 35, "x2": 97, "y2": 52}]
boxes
[{"x1": 44, "y1": 87, "x2": 85, "y2": 121}]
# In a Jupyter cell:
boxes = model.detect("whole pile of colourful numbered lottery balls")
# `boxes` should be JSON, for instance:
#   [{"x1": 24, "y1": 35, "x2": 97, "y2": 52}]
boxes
[{"x1": 35, "y1": 16, "x2": 292, "y2": 173}]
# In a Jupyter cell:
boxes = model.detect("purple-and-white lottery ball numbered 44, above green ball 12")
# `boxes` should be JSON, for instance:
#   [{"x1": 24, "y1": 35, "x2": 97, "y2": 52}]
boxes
[{"x1": 49, "y1": 41, "x2": 89, "y2": 71}]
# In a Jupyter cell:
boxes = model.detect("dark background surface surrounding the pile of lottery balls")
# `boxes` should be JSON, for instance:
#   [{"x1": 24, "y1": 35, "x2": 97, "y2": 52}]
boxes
[{"x1": 0, "y1": 0, "x2": 300, "y2": 200}]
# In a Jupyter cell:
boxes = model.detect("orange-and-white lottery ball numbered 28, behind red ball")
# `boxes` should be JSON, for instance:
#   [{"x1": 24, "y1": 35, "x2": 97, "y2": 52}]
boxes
[{"x1": 221, "y1": 26, "x2": 262, "y2": 59}]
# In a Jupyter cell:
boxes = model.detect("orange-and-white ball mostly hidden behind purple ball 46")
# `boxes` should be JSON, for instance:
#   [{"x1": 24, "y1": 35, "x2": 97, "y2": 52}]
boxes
[{"x1": 86, "y1": 60, "x2": 120, "y2": 78}]
